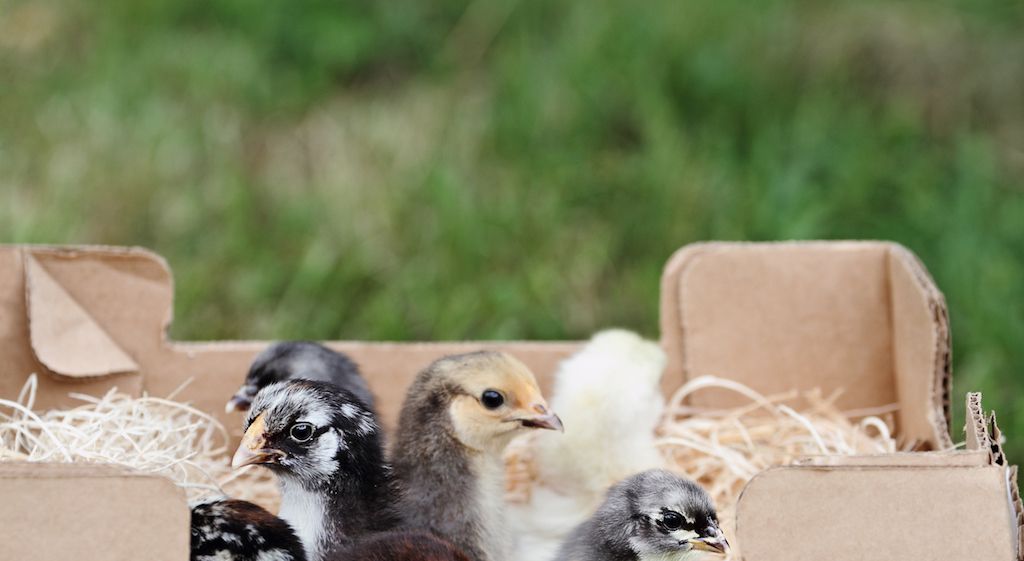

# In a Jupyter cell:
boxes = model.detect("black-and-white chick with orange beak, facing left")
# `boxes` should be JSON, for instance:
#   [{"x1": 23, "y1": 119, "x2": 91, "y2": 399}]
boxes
[{"x1": 231, "y1": 380, "x2": 399, "y2": 561}]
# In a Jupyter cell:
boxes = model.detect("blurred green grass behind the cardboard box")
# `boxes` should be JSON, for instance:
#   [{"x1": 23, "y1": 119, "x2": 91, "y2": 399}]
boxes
[{"x1": 0, "y1": 0, "x2": 1024, "y2": 459}]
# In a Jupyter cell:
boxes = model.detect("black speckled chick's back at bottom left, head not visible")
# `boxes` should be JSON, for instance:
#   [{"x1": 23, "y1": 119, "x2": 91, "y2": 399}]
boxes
[{"x1": 190, "y1": 499, "x2": 306, "y2": 561}]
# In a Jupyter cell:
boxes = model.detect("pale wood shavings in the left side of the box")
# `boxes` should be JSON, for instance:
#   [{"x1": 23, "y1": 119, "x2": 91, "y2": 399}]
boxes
[{"x1": 0, "y1": 375, "x2": 279, "y2": 512}]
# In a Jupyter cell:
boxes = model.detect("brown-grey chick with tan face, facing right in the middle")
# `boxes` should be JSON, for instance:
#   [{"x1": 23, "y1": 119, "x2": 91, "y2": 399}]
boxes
[{"x1": 393, "y1": 351, "x2": 562, "y2": 561}]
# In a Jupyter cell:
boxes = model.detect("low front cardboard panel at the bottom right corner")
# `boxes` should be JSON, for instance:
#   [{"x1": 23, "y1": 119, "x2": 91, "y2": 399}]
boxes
[{"x1": 736, "y1": 466, "x2": 1019, "y2": 561}]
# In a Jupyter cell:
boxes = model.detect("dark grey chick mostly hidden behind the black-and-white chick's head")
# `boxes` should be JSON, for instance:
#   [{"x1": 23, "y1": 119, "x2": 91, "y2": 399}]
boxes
[{"x1": 224, "y1": 341, "x2": 375, "y2": 413}]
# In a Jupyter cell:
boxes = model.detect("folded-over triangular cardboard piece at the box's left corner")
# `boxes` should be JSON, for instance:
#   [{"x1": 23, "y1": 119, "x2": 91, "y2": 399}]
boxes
[{"x1": 25, "y1": 254, "x2": 138, "y2": 378}]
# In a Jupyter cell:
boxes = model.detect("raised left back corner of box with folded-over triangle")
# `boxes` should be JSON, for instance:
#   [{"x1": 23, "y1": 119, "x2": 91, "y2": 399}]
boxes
[{"x1": 0, "y1": 246, "x2": 173, "y2": 409}]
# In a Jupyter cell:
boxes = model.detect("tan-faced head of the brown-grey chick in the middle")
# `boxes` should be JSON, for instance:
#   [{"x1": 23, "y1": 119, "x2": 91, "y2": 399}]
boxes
[{"x1": 430, "y1": 351, "x2": 562, "y2": 452}]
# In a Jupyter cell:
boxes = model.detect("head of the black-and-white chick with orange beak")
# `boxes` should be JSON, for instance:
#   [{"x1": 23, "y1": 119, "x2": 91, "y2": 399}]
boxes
[{"x1": 231, "y1": 380, "x2": 383, "y2": 486}]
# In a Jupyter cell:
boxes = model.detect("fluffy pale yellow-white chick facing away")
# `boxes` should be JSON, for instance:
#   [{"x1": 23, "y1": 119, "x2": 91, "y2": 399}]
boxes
[{"x1": 509, "y1": 330, "x2": 666, "y2": 561}]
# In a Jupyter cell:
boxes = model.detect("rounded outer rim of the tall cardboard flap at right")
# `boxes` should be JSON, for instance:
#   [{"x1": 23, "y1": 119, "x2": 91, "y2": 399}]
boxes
[{"x1": 660, "y1": 241, "x2": 952, "y2": 448}]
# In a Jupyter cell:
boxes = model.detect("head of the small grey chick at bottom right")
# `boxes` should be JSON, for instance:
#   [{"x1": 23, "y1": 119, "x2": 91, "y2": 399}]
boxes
[{"x1": 610, "y1": 470, "x2": 729, "y2": 561}]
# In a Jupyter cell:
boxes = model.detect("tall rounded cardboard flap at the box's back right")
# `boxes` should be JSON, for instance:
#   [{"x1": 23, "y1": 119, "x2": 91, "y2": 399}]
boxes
[{"x1": 662, "y1": 242, "x2": 951, "y2": 448}]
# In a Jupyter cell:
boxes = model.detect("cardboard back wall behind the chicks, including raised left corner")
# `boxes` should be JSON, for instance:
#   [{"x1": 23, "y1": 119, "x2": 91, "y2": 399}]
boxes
[{"x1": 0, "y1": 246, "x2": 579, "y2": 438}]
